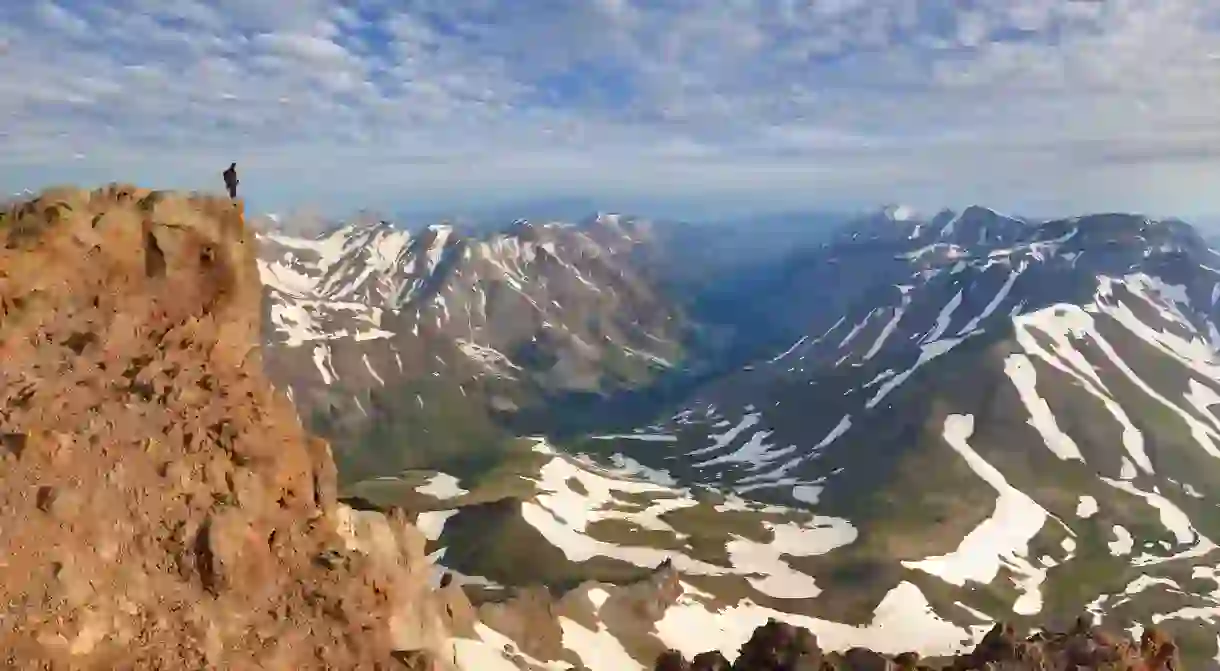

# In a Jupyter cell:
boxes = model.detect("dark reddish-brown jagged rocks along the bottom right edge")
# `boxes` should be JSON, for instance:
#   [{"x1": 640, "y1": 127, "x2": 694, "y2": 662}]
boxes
[{"x1": 654, "y1": 617, "x2": 1180, "y2": 671}]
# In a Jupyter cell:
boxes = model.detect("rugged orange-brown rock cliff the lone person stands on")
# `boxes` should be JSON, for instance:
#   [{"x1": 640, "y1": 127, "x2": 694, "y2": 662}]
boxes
[{"x1": 0, "y1": 185, "x2": 458, "y2": 670}]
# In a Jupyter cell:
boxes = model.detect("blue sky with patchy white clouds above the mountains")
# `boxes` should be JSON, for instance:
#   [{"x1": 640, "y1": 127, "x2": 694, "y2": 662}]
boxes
[{"x1": 0, "y1": 0, "x2": 1220, "y2": 217}]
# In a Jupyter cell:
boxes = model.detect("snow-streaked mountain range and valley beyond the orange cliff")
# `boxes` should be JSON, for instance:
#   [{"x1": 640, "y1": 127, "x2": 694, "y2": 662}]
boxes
[{"x1": 259, "y1": 206, "x2": 1220, "y2": 669}]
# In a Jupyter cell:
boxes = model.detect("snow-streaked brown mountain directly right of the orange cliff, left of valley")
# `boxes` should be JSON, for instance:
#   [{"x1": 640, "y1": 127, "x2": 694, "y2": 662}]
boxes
[{"x1": 260, "y1": 215, "x2": 684, "y2": 476}]
